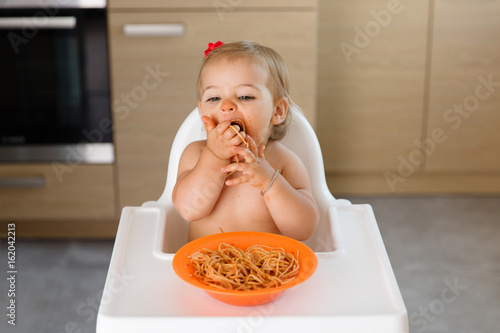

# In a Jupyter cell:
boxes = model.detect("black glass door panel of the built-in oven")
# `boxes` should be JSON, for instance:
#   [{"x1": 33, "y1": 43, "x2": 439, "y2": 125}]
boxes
[{"x1": 0, "y1": 10, "x2": 112, "y2": 146}]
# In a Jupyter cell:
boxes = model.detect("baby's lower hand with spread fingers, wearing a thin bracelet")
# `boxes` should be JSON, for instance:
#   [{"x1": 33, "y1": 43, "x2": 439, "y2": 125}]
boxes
[{"x1": 222, "y1": 135, "x2": 275, "y2": 191}]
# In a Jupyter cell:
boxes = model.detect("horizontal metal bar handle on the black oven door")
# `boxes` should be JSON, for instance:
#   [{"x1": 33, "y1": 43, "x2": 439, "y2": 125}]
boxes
[{"x1": 0, "y1": 16, "x2": 76, "y2": 30}]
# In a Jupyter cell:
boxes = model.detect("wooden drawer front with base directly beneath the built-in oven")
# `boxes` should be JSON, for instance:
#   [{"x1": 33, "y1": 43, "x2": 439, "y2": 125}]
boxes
[{"x1": 0, "y1": 162, "x2": 117, "y2": 238}]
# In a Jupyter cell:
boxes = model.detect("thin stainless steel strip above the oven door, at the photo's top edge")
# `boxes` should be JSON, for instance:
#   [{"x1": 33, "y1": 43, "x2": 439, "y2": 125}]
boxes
[{"x1": 0, "y1": 0, "x2": 107, "y2": 11}]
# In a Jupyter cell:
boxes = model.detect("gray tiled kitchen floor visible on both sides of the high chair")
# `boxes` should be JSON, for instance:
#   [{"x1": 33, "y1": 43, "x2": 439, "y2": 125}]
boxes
[{"x1": 0, "y1": 197, "x2": 500, "y2": 333}]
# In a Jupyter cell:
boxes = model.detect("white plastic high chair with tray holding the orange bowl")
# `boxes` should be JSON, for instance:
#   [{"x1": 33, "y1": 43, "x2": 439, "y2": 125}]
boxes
[{"x1": 97, "y1": 109, "x2": 408, "y2": 333}]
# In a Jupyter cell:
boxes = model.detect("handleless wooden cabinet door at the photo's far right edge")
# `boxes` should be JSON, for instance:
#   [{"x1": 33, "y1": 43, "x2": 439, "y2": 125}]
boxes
[{"x1": 425, "y1": 0, "x2": 500, "y2": 175}]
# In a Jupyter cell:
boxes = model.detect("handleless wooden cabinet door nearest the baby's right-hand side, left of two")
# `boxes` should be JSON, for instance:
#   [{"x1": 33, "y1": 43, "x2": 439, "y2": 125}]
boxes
[{"x1": 318, "y1": 0, "x2": 428, "y2": 174}]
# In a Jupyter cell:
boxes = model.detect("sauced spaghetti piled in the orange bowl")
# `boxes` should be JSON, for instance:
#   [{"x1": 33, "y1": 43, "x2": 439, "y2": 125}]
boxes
[{"x1": 190, "y1": 243, "x2": 299, "y2": 291}]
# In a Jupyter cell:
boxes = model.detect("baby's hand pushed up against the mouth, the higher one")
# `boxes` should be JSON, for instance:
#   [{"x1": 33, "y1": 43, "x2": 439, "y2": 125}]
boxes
[{"x1": 201, "y1": 116, "x2": 245, "y2": 160}]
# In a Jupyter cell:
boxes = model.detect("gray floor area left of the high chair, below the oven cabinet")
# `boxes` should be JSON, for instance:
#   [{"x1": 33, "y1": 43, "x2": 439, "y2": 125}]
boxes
[{"x1": 0, "y1": 240, "x2": 113, "y2": 333}]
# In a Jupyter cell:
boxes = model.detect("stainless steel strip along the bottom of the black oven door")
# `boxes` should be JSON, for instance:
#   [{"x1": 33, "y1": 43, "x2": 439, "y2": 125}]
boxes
[{"x1": 0, "y1": 143, "x2": 115, "y2": 166}]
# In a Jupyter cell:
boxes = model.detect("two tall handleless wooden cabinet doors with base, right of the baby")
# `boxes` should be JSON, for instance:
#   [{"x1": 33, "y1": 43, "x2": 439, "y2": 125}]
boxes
[{"x1": 318, "y1": 0, "x2": 500, "y2": 195}]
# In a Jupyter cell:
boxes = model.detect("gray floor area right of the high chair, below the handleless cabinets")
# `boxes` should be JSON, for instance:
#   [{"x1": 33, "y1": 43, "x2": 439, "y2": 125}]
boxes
[{"x1": 349, "y1": 196, "x2": 500, "y2": 333}]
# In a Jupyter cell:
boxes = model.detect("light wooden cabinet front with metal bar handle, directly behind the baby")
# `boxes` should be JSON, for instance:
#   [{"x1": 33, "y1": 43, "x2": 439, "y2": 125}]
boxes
[{"x1": 109, "y1": 0, "x2": 317, "y2": 207}]
